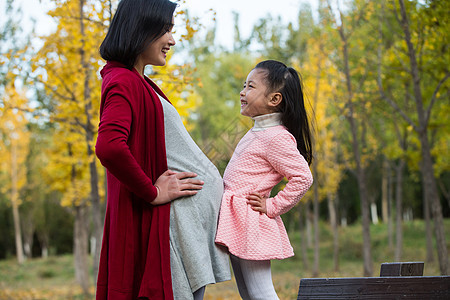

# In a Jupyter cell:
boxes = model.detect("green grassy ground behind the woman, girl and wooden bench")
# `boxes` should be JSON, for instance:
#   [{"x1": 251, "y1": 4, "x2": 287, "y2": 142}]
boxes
[{"x1": 0, "y1": 219, "x2": 450, "y2": 300}]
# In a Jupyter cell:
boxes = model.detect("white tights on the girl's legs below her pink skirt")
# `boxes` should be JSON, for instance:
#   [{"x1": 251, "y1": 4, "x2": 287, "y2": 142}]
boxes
[{"x1": 230, "y1": 254, "x2": 279, "y2": 300}]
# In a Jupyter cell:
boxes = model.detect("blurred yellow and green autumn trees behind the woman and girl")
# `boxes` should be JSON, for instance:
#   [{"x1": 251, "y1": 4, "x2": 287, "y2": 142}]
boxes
[{"x1": 0, "y1": 0, "x2": 450, "y2": 294}]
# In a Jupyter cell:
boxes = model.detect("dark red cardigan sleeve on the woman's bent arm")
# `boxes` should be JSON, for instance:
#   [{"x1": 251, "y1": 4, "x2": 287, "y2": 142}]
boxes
[{"x1": 95, "y1": 83, "x2": 158, "y2": 202}]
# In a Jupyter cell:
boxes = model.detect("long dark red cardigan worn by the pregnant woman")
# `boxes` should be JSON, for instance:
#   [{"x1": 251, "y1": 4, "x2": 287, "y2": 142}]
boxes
[{"x1": 95, "y1": 62, "x2": 173, "y2": 300}]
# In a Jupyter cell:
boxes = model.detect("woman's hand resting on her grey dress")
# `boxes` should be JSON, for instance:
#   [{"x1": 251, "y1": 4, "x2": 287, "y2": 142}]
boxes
[{"x1": 152, "y1": 170, "x2": 204, "y2": 205}]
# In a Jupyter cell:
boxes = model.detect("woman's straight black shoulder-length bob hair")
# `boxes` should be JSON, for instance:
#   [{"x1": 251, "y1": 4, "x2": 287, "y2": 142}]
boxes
[{"x1": 100, "y1": 0, "x2": 177, "y2": 69}]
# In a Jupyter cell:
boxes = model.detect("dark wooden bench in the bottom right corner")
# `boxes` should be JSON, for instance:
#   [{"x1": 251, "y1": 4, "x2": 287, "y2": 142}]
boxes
[{"x1": 297, "y1": 262, "x2": 450, "y2": 300}]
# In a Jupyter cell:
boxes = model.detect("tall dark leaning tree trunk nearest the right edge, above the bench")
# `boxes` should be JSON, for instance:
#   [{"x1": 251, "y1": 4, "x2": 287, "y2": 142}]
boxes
[{"x1": 399, "y1": 0, "x2": 449, "y2": 275}]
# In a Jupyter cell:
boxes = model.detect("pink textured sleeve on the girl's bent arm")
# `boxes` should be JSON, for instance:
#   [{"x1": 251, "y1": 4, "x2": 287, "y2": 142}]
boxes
[{"x1": 266, "y1": 131, "x2": 313, "y2": 218}]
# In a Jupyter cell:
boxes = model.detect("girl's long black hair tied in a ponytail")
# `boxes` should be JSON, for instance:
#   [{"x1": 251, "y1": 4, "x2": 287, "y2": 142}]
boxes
[{"x1": 255, "y1": 60, "x2": 312, "y2": 164}]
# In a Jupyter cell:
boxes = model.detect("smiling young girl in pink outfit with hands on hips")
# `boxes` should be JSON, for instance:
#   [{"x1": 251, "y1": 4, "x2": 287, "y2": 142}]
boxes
[{"x1": 216, "y1": 60, "x2": 313, "y2": 300}]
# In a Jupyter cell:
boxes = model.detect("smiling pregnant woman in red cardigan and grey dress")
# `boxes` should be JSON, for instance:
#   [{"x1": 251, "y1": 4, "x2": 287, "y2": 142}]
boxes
[{"x1": 96, "y1": 0, "x2": 231, "y2": 300}]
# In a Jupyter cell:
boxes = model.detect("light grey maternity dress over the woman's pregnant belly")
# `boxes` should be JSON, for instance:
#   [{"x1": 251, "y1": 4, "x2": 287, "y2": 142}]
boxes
[{"x1": 156, "y1": 93, "x2": 231, "y2": 300}]
